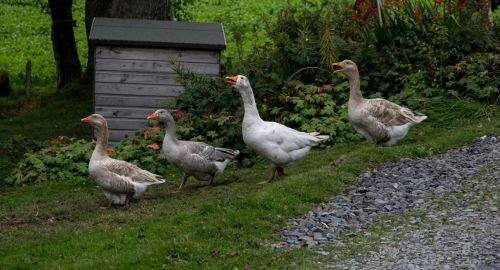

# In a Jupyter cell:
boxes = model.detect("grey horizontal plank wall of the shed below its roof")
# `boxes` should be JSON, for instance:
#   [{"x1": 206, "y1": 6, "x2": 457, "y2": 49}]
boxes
[{"x1": 94, "y1": 46, "x2": 220, "y2": 144}]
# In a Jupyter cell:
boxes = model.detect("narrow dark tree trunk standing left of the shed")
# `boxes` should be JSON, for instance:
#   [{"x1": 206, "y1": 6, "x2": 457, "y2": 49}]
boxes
[{"x1": 49, "y1": 0, "x2": 82, "y2": 89}]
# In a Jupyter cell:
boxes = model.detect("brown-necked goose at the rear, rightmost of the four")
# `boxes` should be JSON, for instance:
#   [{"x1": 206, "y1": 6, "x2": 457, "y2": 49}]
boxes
[{"x1": 334, "y1": 60, "x2": 427, "y2": 146}]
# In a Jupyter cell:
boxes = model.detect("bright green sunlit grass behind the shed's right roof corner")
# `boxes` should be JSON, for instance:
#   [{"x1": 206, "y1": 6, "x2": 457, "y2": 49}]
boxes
[{"x1": 173, "y1": 0, "x2": 322, "y2": 66}]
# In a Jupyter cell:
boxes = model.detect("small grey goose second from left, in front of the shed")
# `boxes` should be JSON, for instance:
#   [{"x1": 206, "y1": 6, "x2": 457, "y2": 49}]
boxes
[{"x1": 148, "y1": 109, "x2": 240, "y2": 192}]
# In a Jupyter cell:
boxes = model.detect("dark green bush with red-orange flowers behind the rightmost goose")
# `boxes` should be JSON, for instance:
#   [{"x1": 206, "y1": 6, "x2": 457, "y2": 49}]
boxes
[{"x1": 348, "y1": 1, "x2": 498, "y2": 106}]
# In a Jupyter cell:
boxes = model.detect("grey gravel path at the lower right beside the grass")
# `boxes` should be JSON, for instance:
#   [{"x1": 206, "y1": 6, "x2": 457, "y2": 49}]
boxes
[{"x1": 273, "y1": 136, "x2": 500, "y2": 269}]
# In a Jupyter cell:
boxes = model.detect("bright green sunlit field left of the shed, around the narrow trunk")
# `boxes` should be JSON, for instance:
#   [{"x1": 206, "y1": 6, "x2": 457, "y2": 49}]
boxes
[{"x1": 0, "y1": 0, "x2": 87, "y2": 92}]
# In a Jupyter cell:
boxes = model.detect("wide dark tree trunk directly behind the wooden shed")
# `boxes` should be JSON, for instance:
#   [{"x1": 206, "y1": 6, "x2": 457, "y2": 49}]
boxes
[{"x1": 85, "y1": 0, "x2": 172, "y2": 80}]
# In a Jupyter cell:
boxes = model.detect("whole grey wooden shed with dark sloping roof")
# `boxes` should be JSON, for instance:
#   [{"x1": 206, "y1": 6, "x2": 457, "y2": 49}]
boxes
[{"x1": 89, "y1": 18, "x2": 226, "y2": 144}]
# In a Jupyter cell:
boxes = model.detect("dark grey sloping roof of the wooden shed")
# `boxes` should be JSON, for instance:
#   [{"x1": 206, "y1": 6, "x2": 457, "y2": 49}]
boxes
[{"x1": 89, "y1": 17, "x2": 226, "y2": 49}]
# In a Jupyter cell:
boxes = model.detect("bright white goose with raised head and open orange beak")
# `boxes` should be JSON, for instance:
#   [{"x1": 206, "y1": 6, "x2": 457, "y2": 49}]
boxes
[{"x1": 226, "y1": 75, "x2": 328, "y2": 184}]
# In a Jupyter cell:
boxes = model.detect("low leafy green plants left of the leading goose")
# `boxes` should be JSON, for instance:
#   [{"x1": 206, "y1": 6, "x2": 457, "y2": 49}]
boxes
[{"x1": 5, "y1": 137, "x2": 94, "y2": 185}]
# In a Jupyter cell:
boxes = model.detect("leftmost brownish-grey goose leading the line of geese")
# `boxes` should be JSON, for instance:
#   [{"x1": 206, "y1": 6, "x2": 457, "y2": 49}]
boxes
[{"x1": 82, "y1": 114, "x2": 165, "y2": 207}]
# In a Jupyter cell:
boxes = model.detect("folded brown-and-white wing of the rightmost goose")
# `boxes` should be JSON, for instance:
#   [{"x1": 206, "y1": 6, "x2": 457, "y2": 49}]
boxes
[{"x1": 362, "y1": 99, "x2": 420, "y2": 126}]
